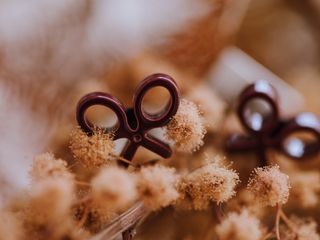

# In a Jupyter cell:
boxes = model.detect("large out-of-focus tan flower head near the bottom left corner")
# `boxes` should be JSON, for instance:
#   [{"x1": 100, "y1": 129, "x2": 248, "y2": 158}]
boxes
[{"x1": 29, "y1": 178, "x2": 74, "y2": 225}]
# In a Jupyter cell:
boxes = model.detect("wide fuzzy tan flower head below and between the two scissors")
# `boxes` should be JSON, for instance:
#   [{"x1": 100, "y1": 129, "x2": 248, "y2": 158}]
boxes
[{"x1": 179, "y1": 163, "x2": 239, "y2": 210}]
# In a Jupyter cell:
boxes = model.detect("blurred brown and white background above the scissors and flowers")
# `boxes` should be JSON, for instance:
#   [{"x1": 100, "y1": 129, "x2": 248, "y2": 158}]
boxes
[{"x1": 0, "y1": 0, "x2": 320, "y2": 239}]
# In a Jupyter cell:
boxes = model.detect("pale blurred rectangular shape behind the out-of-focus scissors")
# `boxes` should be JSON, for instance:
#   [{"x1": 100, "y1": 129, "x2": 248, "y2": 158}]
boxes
[{"x1": 208, "y1": 47, "x2": 304, "y2": 117}]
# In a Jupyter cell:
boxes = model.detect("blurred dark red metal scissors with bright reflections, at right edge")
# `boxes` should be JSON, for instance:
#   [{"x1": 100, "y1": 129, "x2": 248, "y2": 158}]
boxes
[{"x1": 226, "y1": 81, "x2": 320, "y2": 166}]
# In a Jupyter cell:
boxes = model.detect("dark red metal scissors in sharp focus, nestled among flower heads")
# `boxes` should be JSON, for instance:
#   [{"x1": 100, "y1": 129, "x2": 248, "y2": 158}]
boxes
[{"x1": 77, "y1": 74, "x2": 180, "y2": 165}]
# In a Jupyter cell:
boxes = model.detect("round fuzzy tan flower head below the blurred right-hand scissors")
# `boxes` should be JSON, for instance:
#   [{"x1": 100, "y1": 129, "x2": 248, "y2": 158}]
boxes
[{"x1": 248, "y1": 165, "x2": 290, "y2": 207}]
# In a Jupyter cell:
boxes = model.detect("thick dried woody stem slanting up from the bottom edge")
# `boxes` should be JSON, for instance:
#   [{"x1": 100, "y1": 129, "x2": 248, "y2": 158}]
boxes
[{"x1": 89, "y1": 203, "x2": 150, "y2": 240}]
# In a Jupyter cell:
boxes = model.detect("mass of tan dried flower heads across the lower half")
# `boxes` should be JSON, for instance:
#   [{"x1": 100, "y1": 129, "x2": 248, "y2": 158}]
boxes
[{"x1": 1, "y1": 70, "x2": 320, "y2": 240}]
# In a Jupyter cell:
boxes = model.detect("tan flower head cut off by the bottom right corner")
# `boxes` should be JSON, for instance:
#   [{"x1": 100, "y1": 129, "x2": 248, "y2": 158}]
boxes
[{"x1": 281, "y1": 216, "x2": 320, "y2": 240}]
